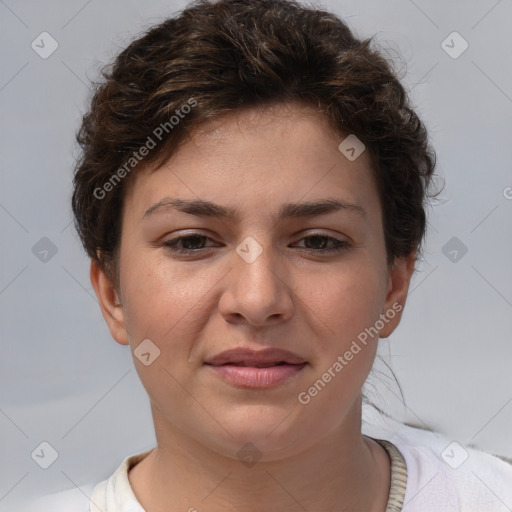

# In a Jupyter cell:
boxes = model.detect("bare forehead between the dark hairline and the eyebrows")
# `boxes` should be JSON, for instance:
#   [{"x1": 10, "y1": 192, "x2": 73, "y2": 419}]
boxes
[{"x1": 125, "y1": 104, "x2": 379, "y2": 223}]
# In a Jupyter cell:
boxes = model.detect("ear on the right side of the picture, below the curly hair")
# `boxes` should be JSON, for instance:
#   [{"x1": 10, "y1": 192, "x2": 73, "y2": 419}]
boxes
[{"x1": 379, "y1": 251, "x2": 416, "y2": 338}]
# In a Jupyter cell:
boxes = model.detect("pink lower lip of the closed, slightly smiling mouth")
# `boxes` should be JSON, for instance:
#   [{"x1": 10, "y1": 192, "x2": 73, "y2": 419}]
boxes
[{"x1": 209, "y1": 363, "x2": 306, "y2": 389}]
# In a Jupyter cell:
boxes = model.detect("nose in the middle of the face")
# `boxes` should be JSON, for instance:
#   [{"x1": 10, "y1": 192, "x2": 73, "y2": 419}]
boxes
[{"x1": 219, "y1": 237, "x2": 294, "y2": 326}]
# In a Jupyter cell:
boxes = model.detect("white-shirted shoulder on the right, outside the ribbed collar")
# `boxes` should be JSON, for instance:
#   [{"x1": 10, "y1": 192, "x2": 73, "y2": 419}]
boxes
[{"x1": 362, "y1": 412, "x2": 512, "y2": 512}]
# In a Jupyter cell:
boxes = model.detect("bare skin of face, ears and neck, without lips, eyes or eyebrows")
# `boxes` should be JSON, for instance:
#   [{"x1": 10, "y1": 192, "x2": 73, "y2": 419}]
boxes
[{"x1": 91, "y1": 104, "x2": 414, "y2": 512}]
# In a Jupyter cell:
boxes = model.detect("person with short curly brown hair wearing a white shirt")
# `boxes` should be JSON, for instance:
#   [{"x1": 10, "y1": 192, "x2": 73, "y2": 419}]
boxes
[{"x1": 69, "y1": 0, "x2": 512, "y2": 512}]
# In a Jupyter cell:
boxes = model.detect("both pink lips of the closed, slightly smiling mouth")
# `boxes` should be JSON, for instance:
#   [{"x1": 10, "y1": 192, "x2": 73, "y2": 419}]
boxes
[{"x1": 205, "y1": 348, "x2": 307, "y2": 389}]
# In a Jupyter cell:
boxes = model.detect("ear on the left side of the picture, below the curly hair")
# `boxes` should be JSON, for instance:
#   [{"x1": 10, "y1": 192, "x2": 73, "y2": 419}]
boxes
[{"x1": 90, "y1": 260, "x2": 129, "y2": 345}]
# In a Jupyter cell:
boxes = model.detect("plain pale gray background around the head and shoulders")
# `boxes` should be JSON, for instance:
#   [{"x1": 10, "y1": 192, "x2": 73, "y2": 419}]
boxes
[{"x1": 0, "y1": 0, "x2": 512, "y2": 510}]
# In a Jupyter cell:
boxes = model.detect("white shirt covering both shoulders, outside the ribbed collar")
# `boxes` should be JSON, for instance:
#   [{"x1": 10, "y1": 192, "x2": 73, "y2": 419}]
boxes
[{"x1": 20, "y1": 416, "x2": 512, "y2": 512}]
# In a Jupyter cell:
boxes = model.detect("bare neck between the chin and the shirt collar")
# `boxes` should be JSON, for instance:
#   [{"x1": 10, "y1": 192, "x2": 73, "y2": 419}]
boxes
[{"x1": 129, "y1": 402, "x2": 390, "y2": 512}]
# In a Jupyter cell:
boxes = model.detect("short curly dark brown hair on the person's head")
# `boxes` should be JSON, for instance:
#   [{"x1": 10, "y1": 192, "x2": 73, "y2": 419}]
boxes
[{"x1": 72, "y1": 0, "x2": 436, "y2": 283}]
